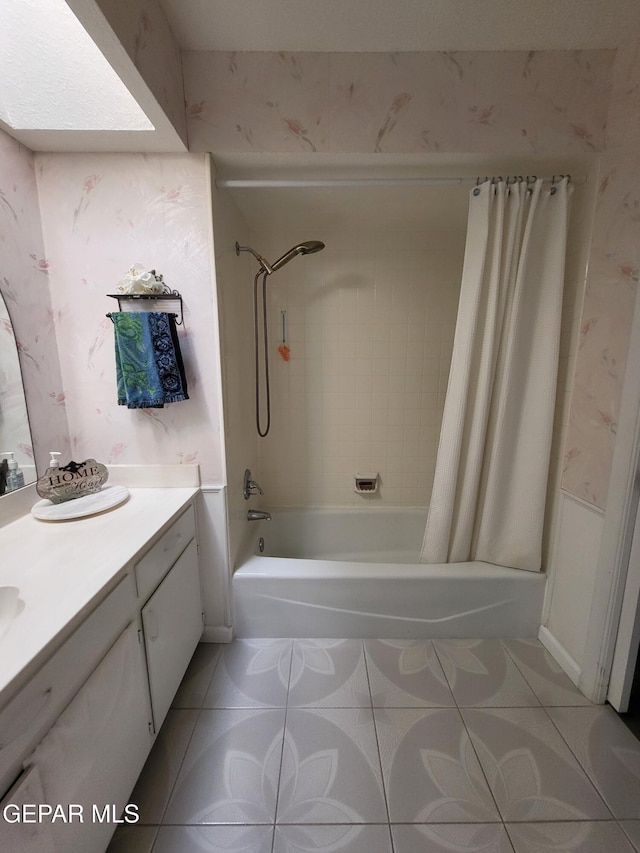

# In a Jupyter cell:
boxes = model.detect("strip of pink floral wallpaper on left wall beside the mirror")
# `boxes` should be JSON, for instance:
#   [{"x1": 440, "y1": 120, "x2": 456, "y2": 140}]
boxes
[{"x1": 0, "y1": 131, "x2": 70, "y2": 476}]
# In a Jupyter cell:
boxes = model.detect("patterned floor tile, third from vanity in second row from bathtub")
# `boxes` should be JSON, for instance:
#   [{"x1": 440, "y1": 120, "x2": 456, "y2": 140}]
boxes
[{"x1": 277, "y1": 708, "x2": 388, "y2": 824}]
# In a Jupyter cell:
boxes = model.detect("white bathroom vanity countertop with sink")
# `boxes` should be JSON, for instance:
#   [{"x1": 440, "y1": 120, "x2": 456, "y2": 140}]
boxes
[{"x1": 0, "y1": 487, "x2": 199, "y2": 706}]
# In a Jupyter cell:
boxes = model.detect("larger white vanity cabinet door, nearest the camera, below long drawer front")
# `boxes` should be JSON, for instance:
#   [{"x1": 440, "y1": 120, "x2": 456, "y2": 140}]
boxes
[{"x1": 16, "y1": 623, "x2": 152, "y2": 853}]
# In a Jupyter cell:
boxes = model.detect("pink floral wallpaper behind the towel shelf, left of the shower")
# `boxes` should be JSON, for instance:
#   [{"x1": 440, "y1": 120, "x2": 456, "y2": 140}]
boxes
[{"x1": 36, "y1": 154, "x2": 224, "y2": 482}]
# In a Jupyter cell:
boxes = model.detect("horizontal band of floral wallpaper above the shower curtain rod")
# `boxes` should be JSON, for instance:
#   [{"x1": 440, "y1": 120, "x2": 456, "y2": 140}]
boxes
[{"x1": 183, "y1": 50, "x2": 614, "y2": 156}]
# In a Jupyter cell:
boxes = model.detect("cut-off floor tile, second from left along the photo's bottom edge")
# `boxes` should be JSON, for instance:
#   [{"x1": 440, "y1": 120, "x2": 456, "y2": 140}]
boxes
[{"x1": 153, "y1": 825, "x2": 273, "y2": 853}]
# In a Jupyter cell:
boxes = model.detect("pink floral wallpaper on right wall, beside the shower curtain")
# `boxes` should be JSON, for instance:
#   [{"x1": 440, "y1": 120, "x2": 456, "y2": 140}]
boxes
[{"x1": 563, "y1": 39, "x2": 640, "y2": 508}]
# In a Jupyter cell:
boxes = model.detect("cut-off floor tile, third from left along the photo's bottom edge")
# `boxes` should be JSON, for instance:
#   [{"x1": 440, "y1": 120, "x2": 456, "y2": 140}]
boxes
[{"x1": 273, "y1": 824, "x2": 392, "y2": 853}]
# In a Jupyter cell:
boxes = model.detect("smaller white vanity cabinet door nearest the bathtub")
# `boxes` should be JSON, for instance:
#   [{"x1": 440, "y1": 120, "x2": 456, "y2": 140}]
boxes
[{"x1": 142, "y1": 539, "x2": 202, "y2": 731}]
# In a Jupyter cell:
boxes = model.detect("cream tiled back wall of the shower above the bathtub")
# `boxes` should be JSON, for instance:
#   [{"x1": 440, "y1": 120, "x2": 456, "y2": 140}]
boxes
[{"x1": 255, "y1": 223, "x2": 466, "y2": 506}]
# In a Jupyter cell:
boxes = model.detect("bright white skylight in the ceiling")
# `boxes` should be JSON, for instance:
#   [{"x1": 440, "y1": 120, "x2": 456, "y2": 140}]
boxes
[{"x1": 0, "y1": 0, "x2": 154, "y2": 131}]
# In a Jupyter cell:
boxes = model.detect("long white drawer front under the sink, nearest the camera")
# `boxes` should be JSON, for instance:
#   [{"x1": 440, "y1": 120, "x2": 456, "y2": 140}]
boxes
[{"x1": 0, "y1": 574, "x2": 136, "y2": 795}]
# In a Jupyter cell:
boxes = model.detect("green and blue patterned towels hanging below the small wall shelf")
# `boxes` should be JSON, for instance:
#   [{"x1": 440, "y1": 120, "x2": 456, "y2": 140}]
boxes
[{"x1": 111, "y1": 311, "x2": 189, "y2": 409}]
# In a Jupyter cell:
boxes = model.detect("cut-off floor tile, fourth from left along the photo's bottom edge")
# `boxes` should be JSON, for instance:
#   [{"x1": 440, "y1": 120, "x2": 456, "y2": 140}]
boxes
[{"x1": 391, "y1": 823, "x2": 513, "y2": 853}]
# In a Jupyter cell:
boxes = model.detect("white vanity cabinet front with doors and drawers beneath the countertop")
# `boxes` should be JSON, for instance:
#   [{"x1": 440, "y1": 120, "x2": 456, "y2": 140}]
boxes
[{"x1": 0, "y1": 490, "x2": 203, "y2": 853}]
